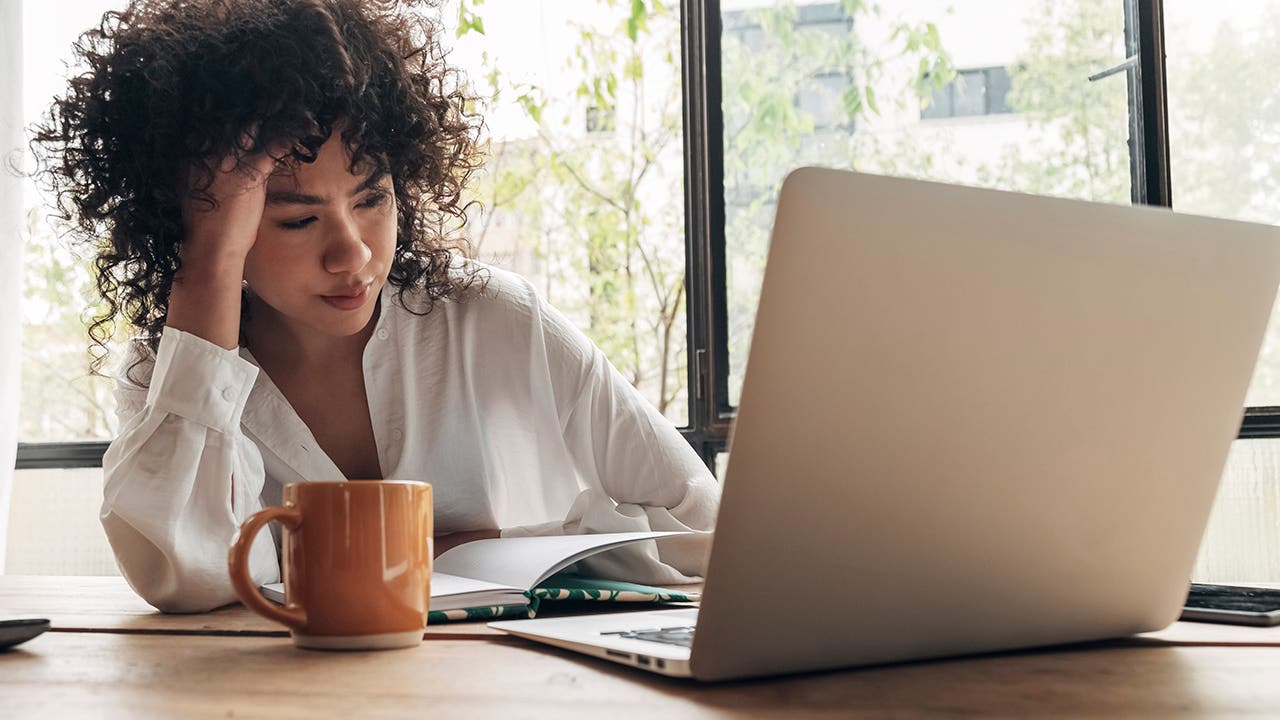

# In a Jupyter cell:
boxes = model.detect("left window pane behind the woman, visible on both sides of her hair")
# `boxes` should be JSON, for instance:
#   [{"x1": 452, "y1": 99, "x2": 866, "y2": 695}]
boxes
[{"x1": 19, "y1": 0, "x2": 687, "y2": 442}]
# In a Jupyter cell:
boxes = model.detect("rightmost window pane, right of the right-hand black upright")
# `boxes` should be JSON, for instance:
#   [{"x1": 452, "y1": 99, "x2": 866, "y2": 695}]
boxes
[{"x1": 1165, "y1": 0, "x2": 1280, "y2": 406}]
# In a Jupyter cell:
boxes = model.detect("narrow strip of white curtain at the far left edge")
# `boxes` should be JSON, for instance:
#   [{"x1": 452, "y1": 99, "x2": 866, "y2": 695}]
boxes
[{"x1": 0, "y1": 0, "x2": 24, "y2": 574}]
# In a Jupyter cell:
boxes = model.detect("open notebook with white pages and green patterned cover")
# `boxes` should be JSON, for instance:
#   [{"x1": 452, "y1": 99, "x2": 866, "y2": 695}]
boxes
[{"x1": 260, "y1": 532, "x2": 698, "y2": 623}]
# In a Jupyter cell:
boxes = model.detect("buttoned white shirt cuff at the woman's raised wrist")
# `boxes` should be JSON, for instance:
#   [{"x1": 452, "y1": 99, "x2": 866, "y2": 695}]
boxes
[{"x1": 147, "y1": 327, "x2": 257, "y2": 434}]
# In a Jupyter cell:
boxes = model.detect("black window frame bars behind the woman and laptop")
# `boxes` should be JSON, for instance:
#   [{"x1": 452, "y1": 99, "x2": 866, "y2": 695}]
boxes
[{"x1": 15, "y1": 0, "x2": 1280, "y2": 470}]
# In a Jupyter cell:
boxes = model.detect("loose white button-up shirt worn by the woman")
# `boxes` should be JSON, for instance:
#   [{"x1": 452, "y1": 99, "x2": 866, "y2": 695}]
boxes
[{"x1": 101, "y1": 266, "x2": 719, "y2": 612}]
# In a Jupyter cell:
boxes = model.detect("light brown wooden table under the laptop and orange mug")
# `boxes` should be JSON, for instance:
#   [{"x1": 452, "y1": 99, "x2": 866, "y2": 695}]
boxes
[{"x1": 0, "y1": 575, "x2": 1280, "y2": 720}]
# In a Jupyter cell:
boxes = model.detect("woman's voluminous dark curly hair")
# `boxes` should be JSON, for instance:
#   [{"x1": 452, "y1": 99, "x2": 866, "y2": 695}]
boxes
[{"x1": 32, "y1": 0, "x2": 484, "y2": 374}]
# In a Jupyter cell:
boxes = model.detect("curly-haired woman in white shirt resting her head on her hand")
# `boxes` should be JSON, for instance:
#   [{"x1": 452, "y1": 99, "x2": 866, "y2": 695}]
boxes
[{"x1": 37, "y1": 0, "x2": 718, "y2": 611}]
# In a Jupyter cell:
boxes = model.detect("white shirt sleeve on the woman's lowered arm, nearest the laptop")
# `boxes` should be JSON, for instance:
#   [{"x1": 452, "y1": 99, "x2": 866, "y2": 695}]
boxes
[{"x1": 503, "y1": 285, "x2": 719, "y2": 583}]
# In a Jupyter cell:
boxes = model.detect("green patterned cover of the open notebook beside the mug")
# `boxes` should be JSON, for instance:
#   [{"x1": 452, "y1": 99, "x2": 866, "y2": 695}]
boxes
[{"x1": 426, "y1": 575, "x2": 701, "y2": 624}]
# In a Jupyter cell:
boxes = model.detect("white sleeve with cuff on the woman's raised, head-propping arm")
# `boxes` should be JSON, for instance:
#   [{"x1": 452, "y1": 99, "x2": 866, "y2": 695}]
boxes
[{"x1": 100, "y1": 328, "x2": 279, "y2": 612}]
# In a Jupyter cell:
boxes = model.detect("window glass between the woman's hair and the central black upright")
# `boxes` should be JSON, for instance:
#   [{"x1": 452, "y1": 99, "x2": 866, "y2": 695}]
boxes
[{"x1": 444, "y1": 0, "x2": 689, "y2": 424}]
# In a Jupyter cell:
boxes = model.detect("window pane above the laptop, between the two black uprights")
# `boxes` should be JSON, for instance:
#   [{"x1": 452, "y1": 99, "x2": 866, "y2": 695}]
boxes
[{"x1": 721, "y1": 0, "x2": 1130, "y2": 405}]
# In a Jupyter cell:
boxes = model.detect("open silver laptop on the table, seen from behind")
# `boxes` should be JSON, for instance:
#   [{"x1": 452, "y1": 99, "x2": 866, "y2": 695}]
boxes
[{"x1": 493, "y1": 168, "x2": 1280, "y2": 680}]
